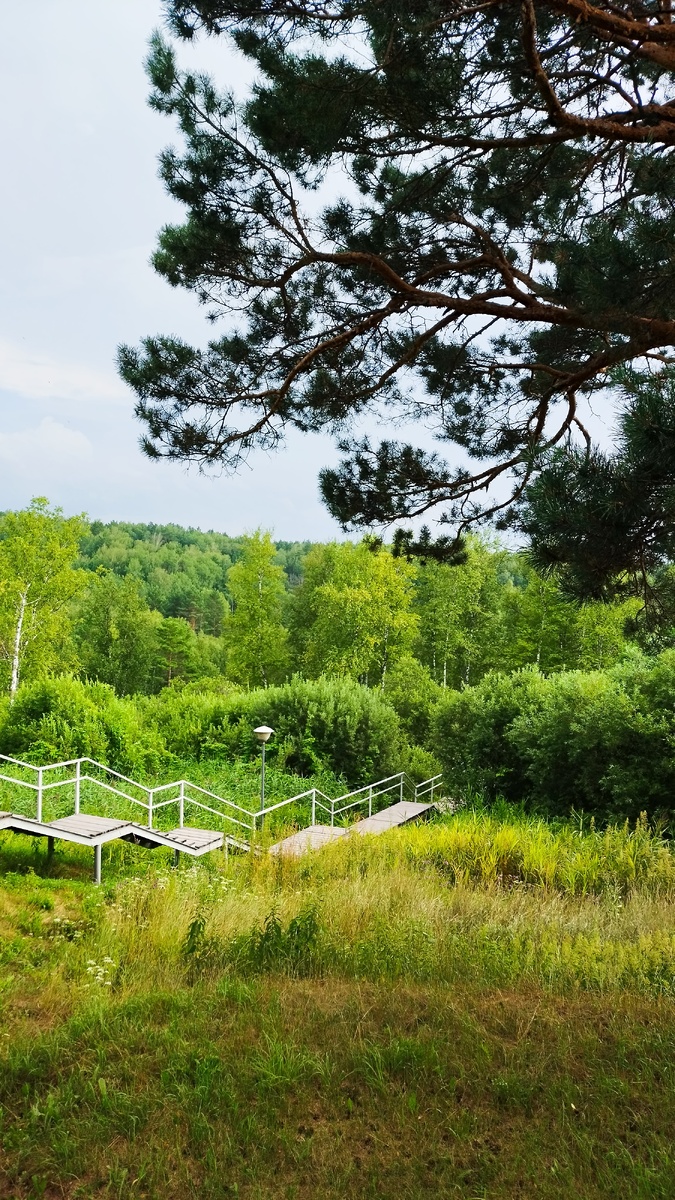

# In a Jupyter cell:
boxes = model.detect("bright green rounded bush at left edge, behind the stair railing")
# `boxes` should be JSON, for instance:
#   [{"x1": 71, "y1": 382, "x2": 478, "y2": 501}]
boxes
[{"x1": 0, "y1": 676, "x2": 168, "y2": 778}]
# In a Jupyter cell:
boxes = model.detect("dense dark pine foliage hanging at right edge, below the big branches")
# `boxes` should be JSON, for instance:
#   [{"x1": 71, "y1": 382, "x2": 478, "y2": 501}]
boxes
[{"x1": 521, "y1": 368, "x2": 675, "y2": 600}]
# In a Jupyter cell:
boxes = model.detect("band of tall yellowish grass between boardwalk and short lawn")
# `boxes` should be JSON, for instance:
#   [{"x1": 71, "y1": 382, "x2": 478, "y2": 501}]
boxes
[{"x1": 10, "y1": 811, "x2": 675, "y2": 995}]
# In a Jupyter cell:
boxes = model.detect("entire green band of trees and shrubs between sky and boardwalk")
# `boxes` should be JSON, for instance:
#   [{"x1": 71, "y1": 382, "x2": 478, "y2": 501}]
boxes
[{"x1": 6, "y1": 500, "x2": 675, "y2": 820}]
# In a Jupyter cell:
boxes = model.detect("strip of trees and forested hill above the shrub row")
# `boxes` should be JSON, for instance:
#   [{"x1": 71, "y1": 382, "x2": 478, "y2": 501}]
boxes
[{"x1": 0, "y1": 499, "x2": 653, "y2": 695}]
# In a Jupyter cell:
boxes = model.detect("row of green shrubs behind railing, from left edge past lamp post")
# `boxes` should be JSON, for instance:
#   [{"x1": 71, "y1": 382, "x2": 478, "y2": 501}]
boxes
[{"x1": 0, "y1": 677, "x2": 398, "y2": 786}]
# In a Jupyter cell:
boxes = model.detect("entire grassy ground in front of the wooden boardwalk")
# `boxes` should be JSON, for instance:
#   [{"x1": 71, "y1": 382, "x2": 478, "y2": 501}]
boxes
[{"x1": 0, "y1": 812, "x2": 675, "y2": 1200}]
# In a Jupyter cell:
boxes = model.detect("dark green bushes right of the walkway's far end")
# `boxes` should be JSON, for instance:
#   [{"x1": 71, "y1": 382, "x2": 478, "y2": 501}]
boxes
[{"x1": 432, "y1": 650, "x2": 675, "y2": 820}]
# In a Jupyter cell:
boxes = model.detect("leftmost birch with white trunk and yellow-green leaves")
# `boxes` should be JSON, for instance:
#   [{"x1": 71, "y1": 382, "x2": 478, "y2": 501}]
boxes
[{"x1": 0, "y1": 498, "x2": 86, "y2": 698}]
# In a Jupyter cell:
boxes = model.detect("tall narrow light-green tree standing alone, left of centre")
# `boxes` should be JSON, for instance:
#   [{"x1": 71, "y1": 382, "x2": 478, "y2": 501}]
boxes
[{"x1": 227, "y1": 530, "x2": 288, "y2": 688}]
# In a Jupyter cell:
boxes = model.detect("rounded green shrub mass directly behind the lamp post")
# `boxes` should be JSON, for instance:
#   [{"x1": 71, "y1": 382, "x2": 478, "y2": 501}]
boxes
[{"x1": 144, "y1": 678, "x2": 401, "y2": 785}]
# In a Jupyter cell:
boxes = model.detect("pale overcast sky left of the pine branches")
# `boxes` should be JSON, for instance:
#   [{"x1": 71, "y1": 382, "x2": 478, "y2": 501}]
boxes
[{"x1": 0, "y1": 0, "x2": 339, "y2": 539}]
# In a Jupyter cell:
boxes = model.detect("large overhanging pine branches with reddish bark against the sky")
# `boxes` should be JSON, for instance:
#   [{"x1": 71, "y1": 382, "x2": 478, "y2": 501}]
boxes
[{"x1": 120, "y1": 0, "x2": 675, "y2": 557}]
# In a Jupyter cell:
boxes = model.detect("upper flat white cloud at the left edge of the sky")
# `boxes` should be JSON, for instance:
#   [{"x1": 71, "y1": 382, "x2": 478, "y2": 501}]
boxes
[{"x1": 0, "y1": 341, "x2": 129, "y2": 400}]
